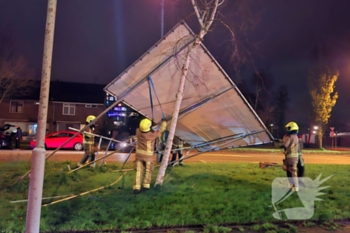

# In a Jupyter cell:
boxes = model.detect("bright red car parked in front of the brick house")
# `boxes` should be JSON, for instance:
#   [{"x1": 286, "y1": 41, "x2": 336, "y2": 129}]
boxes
[{"x1": 29, "y1": 130, "x2": 84, "y2": 150}]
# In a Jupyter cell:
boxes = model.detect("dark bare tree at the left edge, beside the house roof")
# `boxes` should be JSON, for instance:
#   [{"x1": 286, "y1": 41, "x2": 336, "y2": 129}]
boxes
[{"x1": 0, "y1": 37, "x2": 37, "y2": 103}]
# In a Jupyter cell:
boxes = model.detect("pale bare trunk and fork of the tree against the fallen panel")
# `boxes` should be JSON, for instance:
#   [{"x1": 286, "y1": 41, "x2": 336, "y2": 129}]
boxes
[{"x1": 155, "y1": 0, "x2": 224, "y2": 186}]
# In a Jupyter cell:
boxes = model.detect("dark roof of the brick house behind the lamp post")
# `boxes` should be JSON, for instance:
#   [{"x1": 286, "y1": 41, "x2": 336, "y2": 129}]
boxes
[{"x1": 11, "y1": 81, "x2": 106, "y2": 104}]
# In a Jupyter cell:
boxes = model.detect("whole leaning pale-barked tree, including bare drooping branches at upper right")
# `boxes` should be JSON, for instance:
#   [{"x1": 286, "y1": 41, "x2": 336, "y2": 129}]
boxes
[{"x1": 155, "y1": 0, "x2": 262, "y2": 186}]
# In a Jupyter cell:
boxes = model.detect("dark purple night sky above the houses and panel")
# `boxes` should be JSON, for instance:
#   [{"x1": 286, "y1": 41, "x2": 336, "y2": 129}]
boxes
[{"x1": 0, "y1": 0, "x2": 350, "y2": 129}]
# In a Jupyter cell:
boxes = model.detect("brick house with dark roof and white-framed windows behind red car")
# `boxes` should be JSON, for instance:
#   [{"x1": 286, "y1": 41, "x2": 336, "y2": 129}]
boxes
[{"x1": 0, "y1": 81, "x2": 105, "y2": 138}]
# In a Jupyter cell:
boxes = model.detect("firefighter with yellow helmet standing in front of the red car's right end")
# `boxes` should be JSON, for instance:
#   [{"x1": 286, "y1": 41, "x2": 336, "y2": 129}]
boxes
[{"x1": 77, "y1": 115, "x2": 96, "y2": 167}]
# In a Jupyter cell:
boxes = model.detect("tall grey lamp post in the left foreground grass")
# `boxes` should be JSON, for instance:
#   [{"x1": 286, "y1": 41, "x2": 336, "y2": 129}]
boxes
[{"x1": 25, "y1": 0, "x2": 57, "y2": 233}]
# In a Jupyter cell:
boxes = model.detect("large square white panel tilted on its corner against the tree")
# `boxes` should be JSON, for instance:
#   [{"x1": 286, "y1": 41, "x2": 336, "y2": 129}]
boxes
[{"x1": 104, "y1": 22, "x2": 272, "y2": 151}]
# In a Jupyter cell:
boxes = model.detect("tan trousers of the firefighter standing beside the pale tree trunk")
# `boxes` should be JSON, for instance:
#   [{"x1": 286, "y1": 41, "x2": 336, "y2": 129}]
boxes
[{"x1": 133, "y1": 154, "x2": 154, "y2": 190}]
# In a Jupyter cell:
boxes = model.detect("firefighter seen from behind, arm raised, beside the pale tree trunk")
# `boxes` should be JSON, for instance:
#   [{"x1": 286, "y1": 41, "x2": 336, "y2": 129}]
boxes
[{"x1": 133, "y1": 119, "x2": 167, "y2": 194}]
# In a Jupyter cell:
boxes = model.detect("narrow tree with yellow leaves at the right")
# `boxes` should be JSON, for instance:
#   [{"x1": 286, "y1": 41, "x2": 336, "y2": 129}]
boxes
[{"x1": 308, "y1": 65, "x2": 339, "y2": 148}]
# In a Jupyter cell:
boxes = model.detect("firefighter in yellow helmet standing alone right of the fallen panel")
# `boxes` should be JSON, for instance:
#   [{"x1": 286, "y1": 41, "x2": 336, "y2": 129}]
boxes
[{"x1": 281, "y1": 121, "x2": 299, "y2": 191}]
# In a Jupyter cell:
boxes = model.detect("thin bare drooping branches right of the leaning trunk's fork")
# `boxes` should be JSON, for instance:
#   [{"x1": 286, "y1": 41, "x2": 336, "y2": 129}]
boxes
[{"x1": 216, "y1": 0, "x2": 264, "y2": 84}]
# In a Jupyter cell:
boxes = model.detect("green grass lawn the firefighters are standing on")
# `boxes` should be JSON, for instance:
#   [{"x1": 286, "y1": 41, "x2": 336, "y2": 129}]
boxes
[{"x1": 0, "y1": 161, "x2": 350, "y2": 232}]
